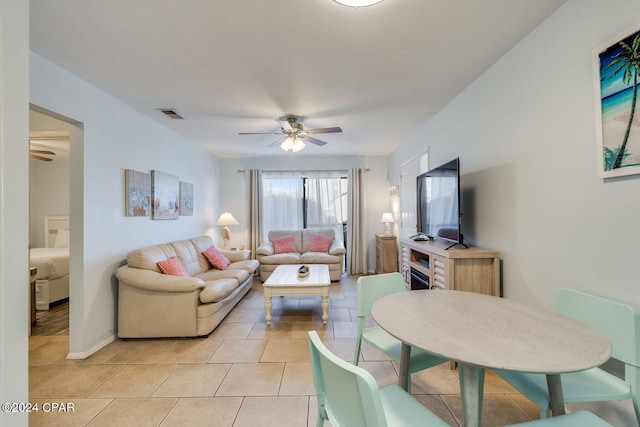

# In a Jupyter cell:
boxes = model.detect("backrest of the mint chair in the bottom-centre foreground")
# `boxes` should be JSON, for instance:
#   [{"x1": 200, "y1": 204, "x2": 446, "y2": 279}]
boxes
[{"x1": 309, "y1": 331, "x2": 387, "y2": 427}]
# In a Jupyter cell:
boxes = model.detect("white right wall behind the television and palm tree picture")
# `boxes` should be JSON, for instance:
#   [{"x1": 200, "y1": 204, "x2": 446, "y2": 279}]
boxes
[{"x1": 390, "y1": 0, "x2": 640, "y2": 425}]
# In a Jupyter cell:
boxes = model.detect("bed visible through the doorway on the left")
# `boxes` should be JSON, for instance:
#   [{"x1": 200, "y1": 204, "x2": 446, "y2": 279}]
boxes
[{"x1": 29, "y1": 216, "x2": 69, "y2": 310}]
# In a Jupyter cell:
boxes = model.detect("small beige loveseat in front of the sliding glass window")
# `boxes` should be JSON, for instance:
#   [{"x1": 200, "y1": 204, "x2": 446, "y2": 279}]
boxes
[{"x1": 256, "y1": 229, "x2": 346, "y2": 282}]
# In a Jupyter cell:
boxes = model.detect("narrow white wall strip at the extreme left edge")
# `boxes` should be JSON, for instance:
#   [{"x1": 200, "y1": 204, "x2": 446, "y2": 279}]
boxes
[{"x1": 0, "y1": 0, "x2": 29, "y2": 426}]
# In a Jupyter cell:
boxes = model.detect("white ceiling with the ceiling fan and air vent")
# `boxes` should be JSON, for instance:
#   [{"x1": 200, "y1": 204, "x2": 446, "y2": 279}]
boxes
[{"x1": 30, "y1": 0, "x2": 565, "y2": 157}]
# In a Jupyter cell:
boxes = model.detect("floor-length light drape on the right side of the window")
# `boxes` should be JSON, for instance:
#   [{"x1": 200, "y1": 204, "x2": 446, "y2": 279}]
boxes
[{"x1": 347, "y1": 168, "x2": 367, "y2": 274}]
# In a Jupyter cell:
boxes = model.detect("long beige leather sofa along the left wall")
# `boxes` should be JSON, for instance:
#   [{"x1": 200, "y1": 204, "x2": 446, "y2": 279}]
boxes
[{"x1": 116, "y1": 236, "x2": 259, "y2": 338}]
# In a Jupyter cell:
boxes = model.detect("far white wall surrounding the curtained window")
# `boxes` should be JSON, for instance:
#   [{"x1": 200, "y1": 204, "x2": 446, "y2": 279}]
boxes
[{"x1": 219, "y1": 154, "x2": 391, "y2": 271}]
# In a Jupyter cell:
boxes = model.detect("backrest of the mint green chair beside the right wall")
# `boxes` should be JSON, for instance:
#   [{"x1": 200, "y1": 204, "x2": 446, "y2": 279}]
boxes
[{"x1": 553, "y1": 288, "x2": 640, "y2": 367}]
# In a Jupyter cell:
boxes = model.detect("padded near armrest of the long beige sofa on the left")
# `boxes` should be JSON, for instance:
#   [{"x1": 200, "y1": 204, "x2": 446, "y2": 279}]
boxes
[{"x1": 116, "y1": 265, "x2": 204, "y2": 292}]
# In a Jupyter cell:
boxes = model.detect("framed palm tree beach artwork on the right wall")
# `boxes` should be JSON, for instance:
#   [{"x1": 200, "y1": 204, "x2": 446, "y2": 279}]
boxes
[{"x1": 593, "y1": 26, "x2": 640, "y2": 178}]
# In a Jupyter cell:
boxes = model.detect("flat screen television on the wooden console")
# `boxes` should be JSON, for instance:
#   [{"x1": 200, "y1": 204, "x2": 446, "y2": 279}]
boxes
[{"x1": 416, "y1": 158, "x2": 463, "y2": 244}]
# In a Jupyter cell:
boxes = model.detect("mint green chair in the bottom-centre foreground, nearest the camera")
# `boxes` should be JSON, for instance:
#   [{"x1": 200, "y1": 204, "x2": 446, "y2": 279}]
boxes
[{"x1": 308, "y1": 331, "x2": 449, "y2": 427}]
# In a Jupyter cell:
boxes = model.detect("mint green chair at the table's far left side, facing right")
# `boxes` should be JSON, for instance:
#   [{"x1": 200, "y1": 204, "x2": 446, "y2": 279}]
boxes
[{"x1": 353, "y1": 273, "x2": 446, "y2": 391}]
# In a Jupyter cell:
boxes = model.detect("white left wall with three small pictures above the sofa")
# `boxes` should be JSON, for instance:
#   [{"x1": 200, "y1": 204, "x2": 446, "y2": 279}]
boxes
[{"x1": 30, "y1": 53, "x2": 225, "y2": 357}]
